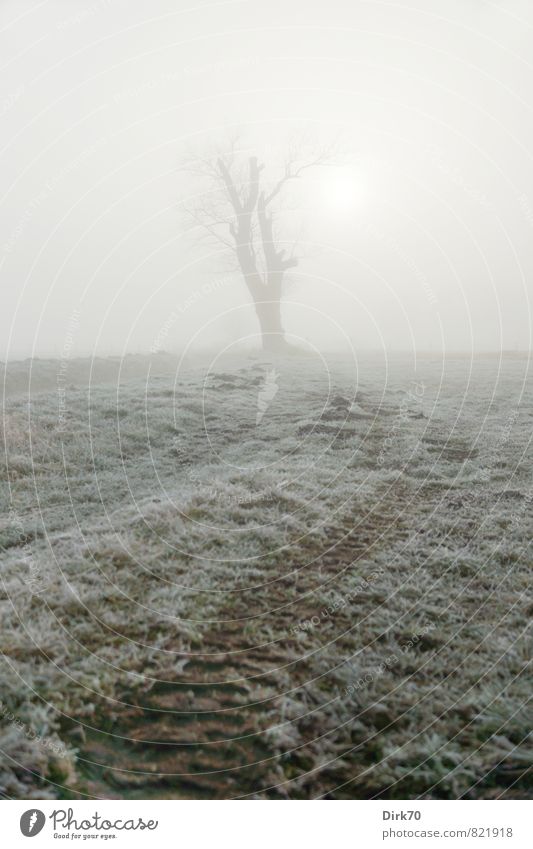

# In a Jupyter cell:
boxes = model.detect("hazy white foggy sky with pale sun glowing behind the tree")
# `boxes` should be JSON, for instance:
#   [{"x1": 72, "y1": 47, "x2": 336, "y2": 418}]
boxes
[{"x1": 0, "y1": 0, "x2": 533, "y2": 359}]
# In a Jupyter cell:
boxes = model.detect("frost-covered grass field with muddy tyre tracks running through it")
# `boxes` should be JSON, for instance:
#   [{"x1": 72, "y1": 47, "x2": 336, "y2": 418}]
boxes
[{"x1": 0, "y1": 353, "x2": 533, "y2": 799}]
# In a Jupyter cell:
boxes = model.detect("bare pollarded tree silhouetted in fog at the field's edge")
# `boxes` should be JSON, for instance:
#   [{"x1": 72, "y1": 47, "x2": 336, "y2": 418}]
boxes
[{"x1": 187, "y1": 142, "x2": 329, "y2": 351}]
